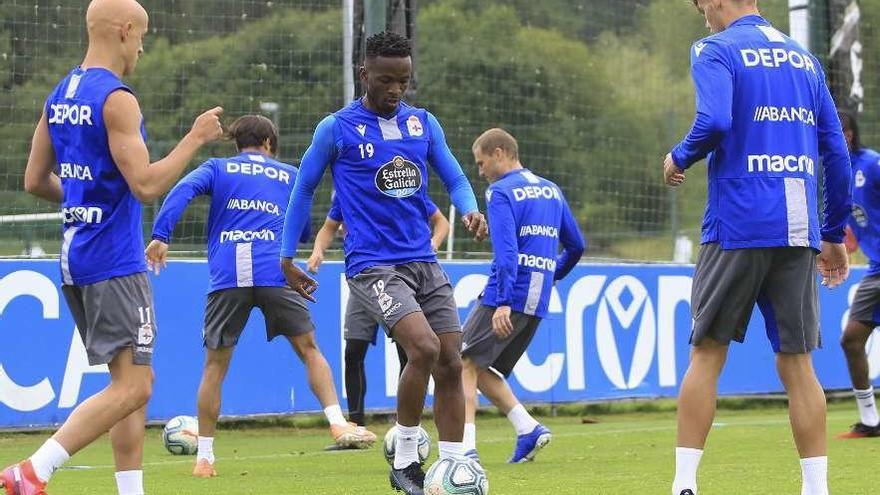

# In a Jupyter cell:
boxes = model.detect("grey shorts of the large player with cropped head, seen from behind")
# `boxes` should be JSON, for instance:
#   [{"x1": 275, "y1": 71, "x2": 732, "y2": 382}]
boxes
[{"x1": 691, "y1": 243, "x2": 822, "y2": 354}]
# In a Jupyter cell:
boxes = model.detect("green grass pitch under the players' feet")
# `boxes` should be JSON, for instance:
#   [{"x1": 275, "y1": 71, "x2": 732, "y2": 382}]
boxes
[{"x1": 0, "y1": 403, "x2": 880, "y2": 495}]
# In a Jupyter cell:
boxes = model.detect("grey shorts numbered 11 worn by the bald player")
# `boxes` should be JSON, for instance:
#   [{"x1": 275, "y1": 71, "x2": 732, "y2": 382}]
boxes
[{"x1": 61, "y1": 273, "x2": 156, "y2": 366}]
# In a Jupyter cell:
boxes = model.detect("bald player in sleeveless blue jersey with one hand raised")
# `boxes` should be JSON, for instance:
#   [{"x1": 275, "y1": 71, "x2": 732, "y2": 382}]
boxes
[{"x1": 13, "y1": 0, "x2": 222, "y2": 495}]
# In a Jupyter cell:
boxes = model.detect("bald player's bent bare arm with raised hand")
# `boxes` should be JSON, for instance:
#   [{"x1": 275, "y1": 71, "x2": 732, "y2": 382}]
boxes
[{"x1": 104, "y1": 91, "x2": 223, "y2": 202}]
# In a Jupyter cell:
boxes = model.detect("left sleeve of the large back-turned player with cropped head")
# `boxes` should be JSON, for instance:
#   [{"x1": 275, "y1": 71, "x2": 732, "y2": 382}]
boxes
[{"x1": 672, "y1": 41, "x2": 733, "y2": 169}]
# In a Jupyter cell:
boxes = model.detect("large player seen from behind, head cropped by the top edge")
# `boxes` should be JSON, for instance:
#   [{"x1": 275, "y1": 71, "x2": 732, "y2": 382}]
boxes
[{"x1": 664, "y1": 0, "x2": 851, "y2": 495}]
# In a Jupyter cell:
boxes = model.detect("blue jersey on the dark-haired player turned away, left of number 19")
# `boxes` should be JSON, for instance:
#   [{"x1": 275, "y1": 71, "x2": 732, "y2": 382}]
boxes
[{"x1": 153, "y1": 153, "x2": 309, "y2": 292}]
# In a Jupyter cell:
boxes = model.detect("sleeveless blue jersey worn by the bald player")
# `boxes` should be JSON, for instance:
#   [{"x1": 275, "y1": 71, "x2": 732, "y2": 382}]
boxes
[{"x1": 45, "y1": 67, "x2": 147, "y2": 285}]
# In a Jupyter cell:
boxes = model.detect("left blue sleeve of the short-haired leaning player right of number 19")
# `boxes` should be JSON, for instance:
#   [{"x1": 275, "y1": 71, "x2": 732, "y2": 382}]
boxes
[{"x1": 487, "y1": 191, "x2": 519, "y2": 306}]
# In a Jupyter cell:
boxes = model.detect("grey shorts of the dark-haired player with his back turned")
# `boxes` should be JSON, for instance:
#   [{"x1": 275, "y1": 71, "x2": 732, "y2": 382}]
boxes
[{"x1": 202, "y1": 287, "x2": 315, "y2": 349}]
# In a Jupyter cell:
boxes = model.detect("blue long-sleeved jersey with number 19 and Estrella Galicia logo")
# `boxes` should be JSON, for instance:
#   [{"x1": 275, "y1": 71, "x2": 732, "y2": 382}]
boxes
[{"x1": 281, "y1": 99, "x2": 478, "y2": 277}]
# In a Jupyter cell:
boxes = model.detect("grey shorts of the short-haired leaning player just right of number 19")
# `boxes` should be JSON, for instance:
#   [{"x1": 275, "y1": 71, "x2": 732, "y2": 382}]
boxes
[{"x1": 461, "y1": 304, "x2": 541, "y2": 377}]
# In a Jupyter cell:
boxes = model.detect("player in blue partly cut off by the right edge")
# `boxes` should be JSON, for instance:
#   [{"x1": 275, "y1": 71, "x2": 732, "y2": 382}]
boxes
[{"x1": 838, "y1": 112, "x2": 880, "y2": 438}]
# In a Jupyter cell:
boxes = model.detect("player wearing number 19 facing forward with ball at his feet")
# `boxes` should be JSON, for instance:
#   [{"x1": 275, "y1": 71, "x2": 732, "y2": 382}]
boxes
[{"x1": 281, "y1": 32, "x2": 486, "y2": 494}]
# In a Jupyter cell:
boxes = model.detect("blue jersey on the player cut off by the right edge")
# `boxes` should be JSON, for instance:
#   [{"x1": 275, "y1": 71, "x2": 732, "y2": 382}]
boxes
[{"x1": 849, "y1": 148, "x2": 880, "y2": 276}]
